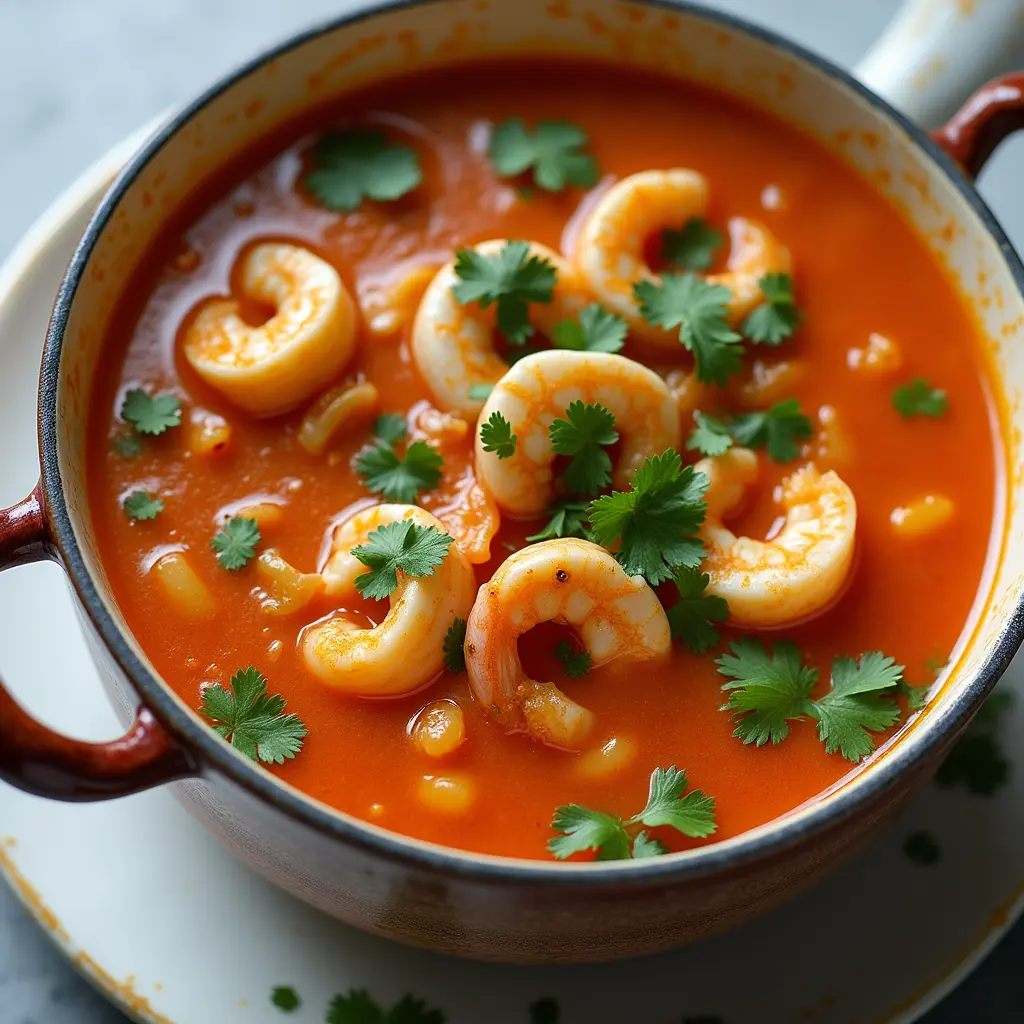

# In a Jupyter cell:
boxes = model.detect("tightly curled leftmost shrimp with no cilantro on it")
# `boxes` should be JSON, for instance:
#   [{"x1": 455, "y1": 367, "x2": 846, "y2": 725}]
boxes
[{"x1": 184, "y1": 242, "x2": 356, "y2": 416}]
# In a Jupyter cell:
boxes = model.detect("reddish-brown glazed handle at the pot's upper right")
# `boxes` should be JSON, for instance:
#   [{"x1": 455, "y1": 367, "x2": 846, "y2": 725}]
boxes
[{"x1": 932, "y1": 72, "x2": 1024, "y2": 178}]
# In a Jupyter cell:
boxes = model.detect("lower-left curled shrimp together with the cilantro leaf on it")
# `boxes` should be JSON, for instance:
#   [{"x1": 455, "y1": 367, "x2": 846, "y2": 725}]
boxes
[{"x1": 299, "y1": 505, "x2": 476, "y2": 697}]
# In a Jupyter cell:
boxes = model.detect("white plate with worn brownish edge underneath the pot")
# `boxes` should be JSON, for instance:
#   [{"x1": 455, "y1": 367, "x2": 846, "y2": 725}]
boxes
[{"x1": 0, "y1": 137, "x2": 1024, "y2": 1024}]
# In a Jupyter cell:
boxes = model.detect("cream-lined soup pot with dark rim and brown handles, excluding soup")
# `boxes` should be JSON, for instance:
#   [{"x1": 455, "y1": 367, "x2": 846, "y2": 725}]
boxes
[{"x1": 0, "y1": 0, "x2": 1024, "y2": 962}]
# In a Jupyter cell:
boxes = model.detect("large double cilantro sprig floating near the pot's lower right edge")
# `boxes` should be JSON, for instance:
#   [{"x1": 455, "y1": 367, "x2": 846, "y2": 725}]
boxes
[{"x1": 716, "y1": 637, "x2": 903, "y2": 763}]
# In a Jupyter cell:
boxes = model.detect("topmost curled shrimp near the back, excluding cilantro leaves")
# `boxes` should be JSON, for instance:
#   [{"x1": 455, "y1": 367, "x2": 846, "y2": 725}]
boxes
[{"x1": 575, "y1": 167, "x2": 792, "y2": 348}]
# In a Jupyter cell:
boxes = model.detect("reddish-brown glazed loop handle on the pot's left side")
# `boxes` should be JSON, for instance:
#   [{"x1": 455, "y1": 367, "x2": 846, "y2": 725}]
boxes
[{"x1": 0, "y1": 487, "x2": 198, "y2": 801}]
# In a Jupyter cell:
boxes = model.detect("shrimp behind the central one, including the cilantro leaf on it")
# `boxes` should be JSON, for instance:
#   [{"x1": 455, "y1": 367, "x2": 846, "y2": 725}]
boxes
[{"x1": 412, "y1": 239, "x2": 593, "y2": 417}]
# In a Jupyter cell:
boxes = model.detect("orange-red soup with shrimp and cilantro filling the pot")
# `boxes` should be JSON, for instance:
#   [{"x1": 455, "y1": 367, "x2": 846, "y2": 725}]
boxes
[{"x1": 89, "y1": 61, "x2": 1002, "y2": 859}]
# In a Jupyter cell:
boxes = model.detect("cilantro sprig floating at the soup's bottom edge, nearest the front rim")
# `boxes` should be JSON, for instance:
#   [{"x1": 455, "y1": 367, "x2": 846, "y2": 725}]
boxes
[{"x1": 548, "y1": 765, "x2": 716, "y2": 860}]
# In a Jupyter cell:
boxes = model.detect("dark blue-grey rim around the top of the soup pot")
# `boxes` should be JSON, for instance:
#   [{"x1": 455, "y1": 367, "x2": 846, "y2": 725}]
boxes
[{"x1": 38, "y1": 0, "x2": 1024, "y2": 888}]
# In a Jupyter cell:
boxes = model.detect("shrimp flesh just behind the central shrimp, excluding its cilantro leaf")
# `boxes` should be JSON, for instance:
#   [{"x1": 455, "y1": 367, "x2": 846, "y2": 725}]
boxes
[{"x1": 412, "y1": 239, "x2": 592, "y2": 418}]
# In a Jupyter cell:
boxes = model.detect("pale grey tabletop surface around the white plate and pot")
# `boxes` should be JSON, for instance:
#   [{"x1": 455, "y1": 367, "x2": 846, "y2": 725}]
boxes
[{"x1": 0, "y1": 0, "x2": 1024, "y2": 1024}]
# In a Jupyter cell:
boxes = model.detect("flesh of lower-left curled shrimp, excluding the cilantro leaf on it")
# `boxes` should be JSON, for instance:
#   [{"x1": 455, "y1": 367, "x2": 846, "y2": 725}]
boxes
[{"x1": 300, "y1": 505, "x2": 476, "y2": 697}]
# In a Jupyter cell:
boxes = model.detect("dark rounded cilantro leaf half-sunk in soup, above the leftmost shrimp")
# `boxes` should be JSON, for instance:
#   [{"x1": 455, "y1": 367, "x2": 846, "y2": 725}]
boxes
[{"x1": 305, "y1": 130, "x2": 423, "y2": 213}]
